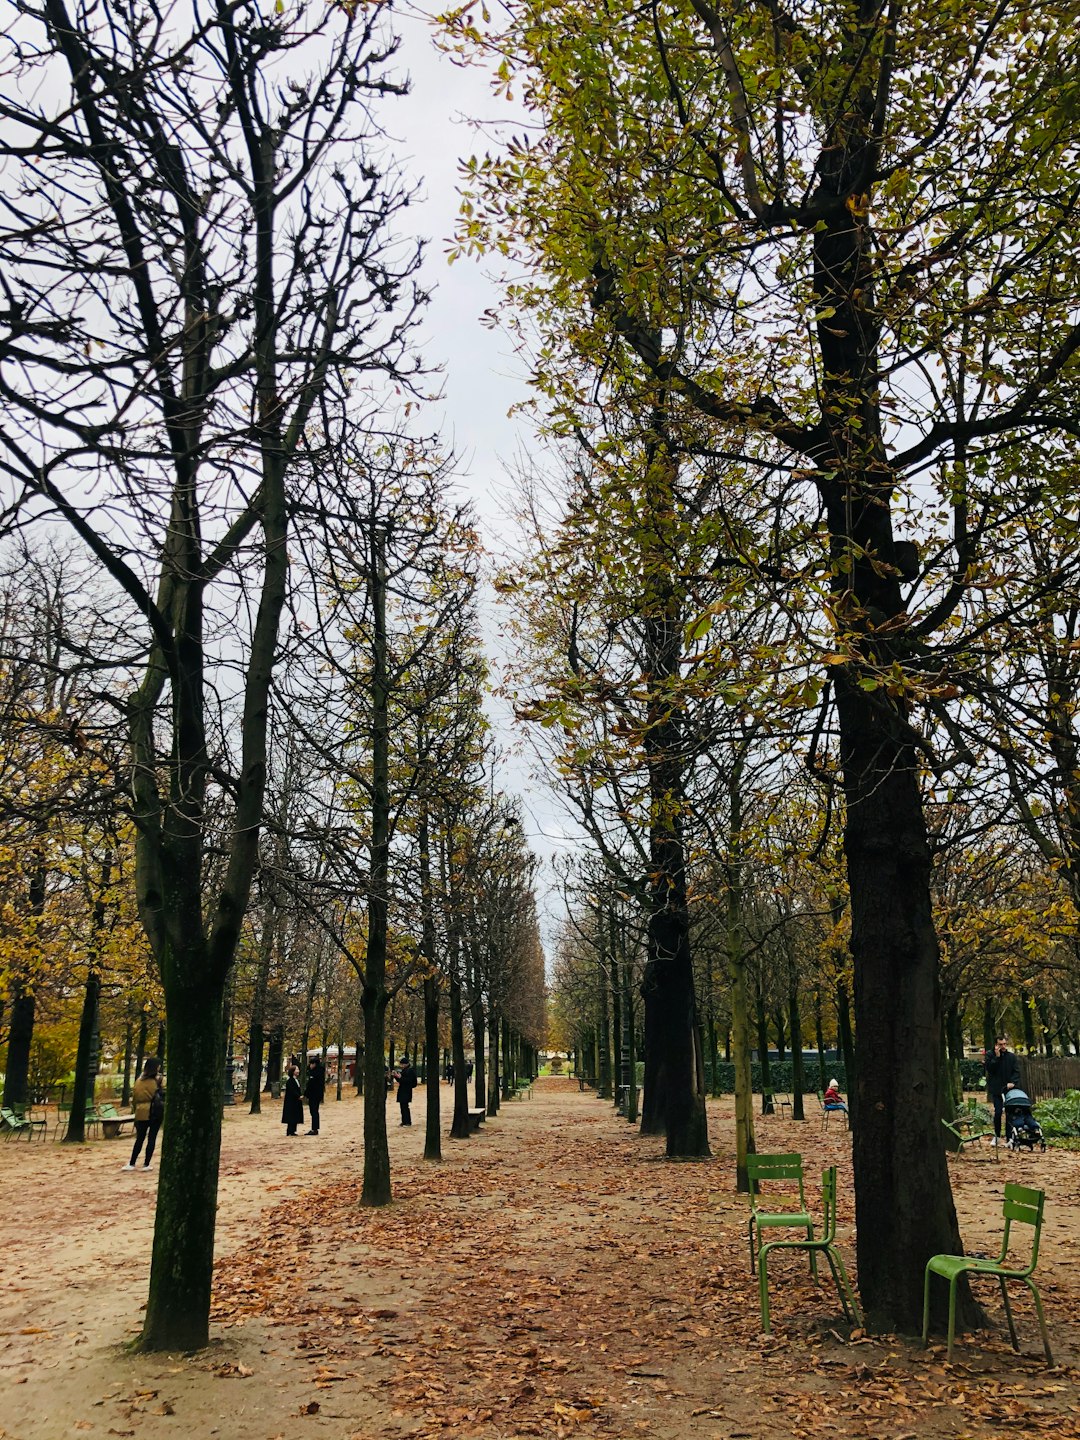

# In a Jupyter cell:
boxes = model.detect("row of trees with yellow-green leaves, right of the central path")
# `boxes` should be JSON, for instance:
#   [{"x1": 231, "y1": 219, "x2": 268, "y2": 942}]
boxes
[{"x1": 446, "y1": 0, "x2": 1080, "y2": 1329}]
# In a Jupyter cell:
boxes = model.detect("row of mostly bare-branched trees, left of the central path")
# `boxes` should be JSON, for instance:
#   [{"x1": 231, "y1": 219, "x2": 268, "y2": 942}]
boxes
[{"x1": 0, "y1": 0, "x2": 541, "y2": 1349}]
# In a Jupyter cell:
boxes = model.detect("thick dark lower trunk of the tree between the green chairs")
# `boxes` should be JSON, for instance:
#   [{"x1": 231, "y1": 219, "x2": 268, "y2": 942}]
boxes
[{"x1": 838, "y1": 683, "x2": 972, "y2": 1333}]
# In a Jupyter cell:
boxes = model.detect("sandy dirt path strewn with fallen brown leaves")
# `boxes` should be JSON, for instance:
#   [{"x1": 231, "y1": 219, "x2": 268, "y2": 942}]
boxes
[{"x1": 0, "y1": 1080, "x2": 1080, "y2": 1440}]
